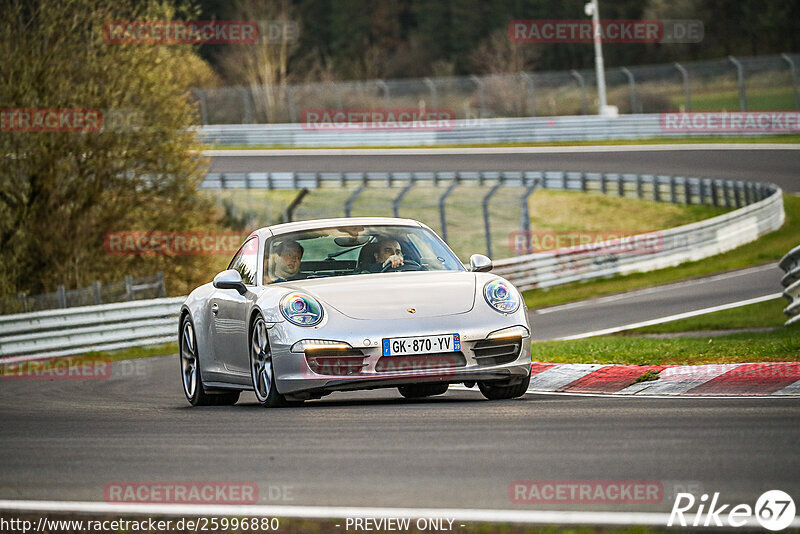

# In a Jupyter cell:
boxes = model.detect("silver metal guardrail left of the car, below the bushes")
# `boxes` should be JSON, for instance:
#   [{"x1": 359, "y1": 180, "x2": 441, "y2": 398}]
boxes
[{"x1": 0, "y1": 297, "x2": 185, "y2": 358}]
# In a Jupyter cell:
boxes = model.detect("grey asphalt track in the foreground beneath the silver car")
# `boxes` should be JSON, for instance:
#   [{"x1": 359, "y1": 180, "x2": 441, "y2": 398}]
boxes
[{"x1": 0, "y1": 356, "x2": 800, "y2": 511}]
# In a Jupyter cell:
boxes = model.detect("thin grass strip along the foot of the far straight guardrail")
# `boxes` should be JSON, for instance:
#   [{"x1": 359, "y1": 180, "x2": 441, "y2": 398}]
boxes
[{"x1": 206, "y1": 134, "x2": 800, "y2": 150}]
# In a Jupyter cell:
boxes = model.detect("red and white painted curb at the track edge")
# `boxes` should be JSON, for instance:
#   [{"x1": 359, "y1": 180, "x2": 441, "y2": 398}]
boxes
[{"x1": 528, "y1": 362, "x2": 800, "y2": 397}]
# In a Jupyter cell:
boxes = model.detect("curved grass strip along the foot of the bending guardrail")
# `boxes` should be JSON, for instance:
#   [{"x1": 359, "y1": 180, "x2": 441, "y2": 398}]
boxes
[{"x1": 523, "y1": 195, "x2": 800, "y2": 308}]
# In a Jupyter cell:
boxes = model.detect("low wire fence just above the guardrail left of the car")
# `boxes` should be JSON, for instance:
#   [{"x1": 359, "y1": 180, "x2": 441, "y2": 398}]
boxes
[{"x1": 0, "y1": 272, "x2": 167, "y2": 315}]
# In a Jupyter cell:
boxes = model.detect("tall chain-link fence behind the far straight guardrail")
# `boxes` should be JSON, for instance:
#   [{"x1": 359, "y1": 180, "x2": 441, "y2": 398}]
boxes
[{"x1": 193, "y1": 54, "x2": 800, "y2": 124}]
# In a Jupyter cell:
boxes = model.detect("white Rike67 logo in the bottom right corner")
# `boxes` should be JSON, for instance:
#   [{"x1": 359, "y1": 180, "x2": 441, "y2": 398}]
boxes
[{"x1": 667, "y1": 490, "x2": 796, "y2": 531}]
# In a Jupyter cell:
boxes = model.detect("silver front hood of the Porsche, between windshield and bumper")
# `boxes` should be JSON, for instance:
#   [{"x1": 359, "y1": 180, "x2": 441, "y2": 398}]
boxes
[{"x1": 287, "y1": 271, "x2": 475, "y2": 319}]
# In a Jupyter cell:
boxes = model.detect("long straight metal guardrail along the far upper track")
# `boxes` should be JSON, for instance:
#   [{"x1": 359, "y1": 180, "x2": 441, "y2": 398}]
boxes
[{"x1": 196, "y1": 112, "x2": 797, "y2": 147}]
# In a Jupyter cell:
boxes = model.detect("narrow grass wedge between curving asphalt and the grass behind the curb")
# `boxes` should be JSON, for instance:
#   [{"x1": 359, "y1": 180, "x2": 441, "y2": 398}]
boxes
[{"x1": 626, "y1": 298, "x2": 787, "y2": 335}]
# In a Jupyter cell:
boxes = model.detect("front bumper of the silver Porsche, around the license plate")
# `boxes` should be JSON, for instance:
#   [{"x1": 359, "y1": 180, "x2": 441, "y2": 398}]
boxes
[{"x1": 269, "y1": 311, "x2": 531, "y2": 398}]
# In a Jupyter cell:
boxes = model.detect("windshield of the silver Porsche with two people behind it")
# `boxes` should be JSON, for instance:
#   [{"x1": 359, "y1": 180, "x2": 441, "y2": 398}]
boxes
[{"x1": 264, "y1": 226, "x2": 464, "y2": 284}]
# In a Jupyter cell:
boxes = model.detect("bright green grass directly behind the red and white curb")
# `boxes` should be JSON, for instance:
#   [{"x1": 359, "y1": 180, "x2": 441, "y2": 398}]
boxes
[{"x1": 531, "y1": 327, "x2": 800, "y2": 365}]
